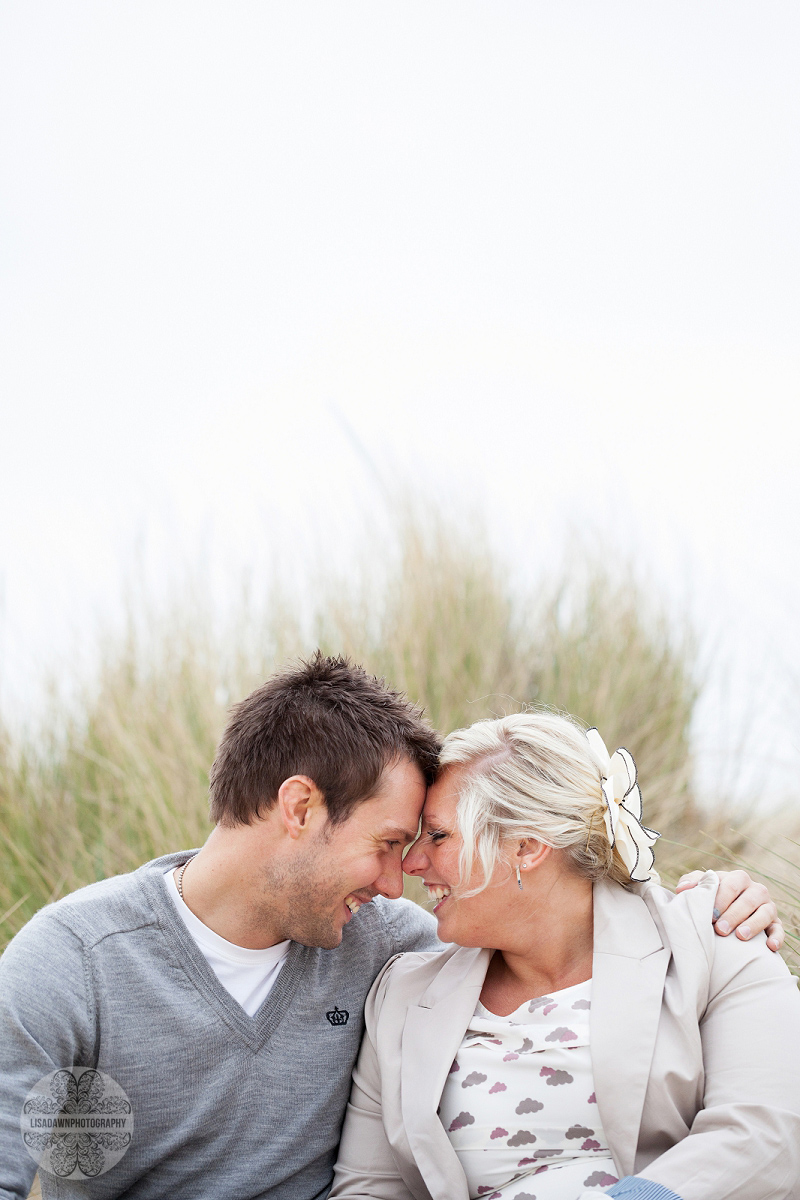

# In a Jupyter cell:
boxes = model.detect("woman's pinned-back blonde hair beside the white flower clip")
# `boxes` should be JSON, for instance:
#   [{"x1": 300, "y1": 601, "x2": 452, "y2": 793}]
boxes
[{"x1": 440, "y1": 710, "x2": 631, "y2": 894}]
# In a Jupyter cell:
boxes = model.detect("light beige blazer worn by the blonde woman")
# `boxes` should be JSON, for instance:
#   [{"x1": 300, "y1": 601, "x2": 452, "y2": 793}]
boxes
[{"x1": 330, "y1": 871, "x2": 800, "y2": 1200}]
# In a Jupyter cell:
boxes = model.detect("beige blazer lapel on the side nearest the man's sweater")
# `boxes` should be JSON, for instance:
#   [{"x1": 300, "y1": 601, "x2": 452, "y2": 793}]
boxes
[{"x1": 401, "y1": 949, "x2": 492, "y2": 1200}]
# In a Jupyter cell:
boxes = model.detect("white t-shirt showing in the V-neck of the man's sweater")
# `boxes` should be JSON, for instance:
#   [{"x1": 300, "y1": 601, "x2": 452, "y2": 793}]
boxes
[{"x1": 164, "y1": 866, "x2": 291, "y2": 1016}]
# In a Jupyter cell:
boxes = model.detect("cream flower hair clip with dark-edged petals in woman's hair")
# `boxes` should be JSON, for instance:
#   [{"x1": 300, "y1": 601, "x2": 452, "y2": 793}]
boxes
[{"x1": 587, "y1": 728, "x2": 661, "y2": 883}]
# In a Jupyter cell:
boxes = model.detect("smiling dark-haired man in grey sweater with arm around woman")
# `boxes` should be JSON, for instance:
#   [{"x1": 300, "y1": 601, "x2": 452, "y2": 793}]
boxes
[{"x1": 0, "y1": 654, "x2": 774, "y2": 1200}]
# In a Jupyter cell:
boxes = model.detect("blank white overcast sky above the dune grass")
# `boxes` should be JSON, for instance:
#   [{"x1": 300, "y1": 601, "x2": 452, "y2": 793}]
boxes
[{"x1": 0, "y1": 0, "x2": 800, "y2": 794}]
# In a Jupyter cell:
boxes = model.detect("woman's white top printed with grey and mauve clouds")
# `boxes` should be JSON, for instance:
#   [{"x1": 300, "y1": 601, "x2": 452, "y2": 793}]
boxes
[{"x1": 439, "y1": 979, "x2": 618, "y2": 1200}]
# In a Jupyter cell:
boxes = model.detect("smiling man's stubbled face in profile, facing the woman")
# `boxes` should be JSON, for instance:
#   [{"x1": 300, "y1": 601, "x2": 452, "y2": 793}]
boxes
[{"x1": 267, "y1": 758, "x2": 426, "y2": 949}]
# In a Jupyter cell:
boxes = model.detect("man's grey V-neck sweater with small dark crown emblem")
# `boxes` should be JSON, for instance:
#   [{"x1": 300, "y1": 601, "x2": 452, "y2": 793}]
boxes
[{"x1": 0, "y1": 852, "x2": 441, "y2": 1200}]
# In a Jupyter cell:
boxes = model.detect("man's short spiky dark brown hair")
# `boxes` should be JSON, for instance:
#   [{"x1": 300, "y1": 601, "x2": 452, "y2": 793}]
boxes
[{"x1": 210, "y1": 650, "x2": 441, "y2": 826}]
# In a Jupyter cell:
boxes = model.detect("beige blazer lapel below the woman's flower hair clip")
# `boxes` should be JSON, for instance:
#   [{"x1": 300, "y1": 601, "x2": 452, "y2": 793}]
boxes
[{"x1": 591, "y1": 883, "x2": 670, "y2": 1175}]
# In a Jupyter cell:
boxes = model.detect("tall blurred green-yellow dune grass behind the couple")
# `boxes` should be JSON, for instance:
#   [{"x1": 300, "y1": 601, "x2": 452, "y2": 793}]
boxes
[{"x1": 0, "y1": 515, "x2": 799, "y2": 964}]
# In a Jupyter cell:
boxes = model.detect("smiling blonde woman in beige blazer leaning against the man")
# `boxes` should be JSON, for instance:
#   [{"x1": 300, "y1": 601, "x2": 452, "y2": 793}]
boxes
[{"x1": 331, "y1": 713, "x2": 800, "y2": 1200}]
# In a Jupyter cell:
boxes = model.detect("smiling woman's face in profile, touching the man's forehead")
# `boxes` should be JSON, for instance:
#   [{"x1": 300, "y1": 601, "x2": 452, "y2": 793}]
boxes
[{"x1": 403, "y1": 767, "x2": 519, "y2": 949}]
